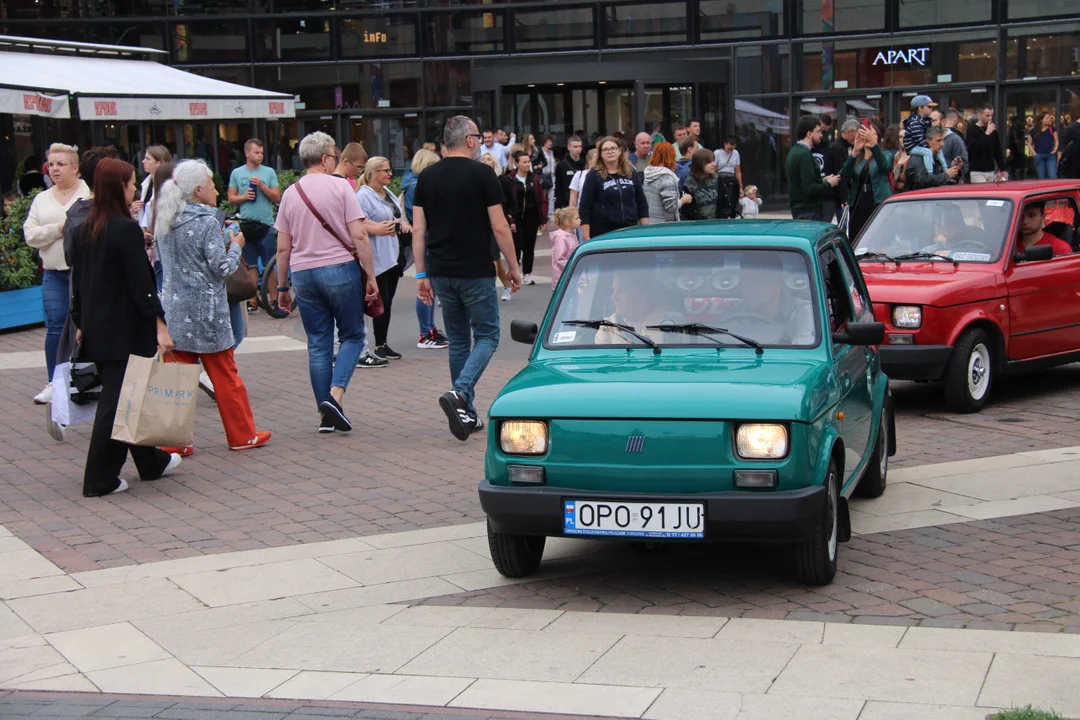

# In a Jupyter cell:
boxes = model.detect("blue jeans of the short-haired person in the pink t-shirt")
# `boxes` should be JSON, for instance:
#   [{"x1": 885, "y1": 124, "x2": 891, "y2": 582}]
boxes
[{"x1": 292, "y1": 260, "x2": 365, "y2": 405}]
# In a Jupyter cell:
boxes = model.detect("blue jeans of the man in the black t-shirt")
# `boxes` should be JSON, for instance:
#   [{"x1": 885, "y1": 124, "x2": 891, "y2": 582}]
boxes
[{"x1": 431, "y1": 277, "x2": 499, "y2": 416}]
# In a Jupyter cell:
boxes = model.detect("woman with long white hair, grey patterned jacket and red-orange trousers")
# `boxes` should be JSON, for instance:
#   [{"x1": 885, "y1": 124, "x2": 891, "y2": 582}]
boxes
[{"x1": 154, "y1": 160, "x2": 270, "y2": 456}]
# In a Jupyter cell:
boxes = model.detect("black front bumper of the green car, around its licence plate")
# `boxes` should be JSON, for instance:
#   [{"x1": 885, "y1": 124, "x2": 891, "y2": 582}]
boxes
[{"x1": 480, "y1": 480, "x2": 825, "y2": 541}]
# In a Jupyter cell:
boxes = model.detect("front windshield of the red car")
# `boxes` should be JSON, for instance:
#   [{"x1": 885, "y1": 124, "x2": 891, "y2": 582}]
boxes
[{"x1": 855, "y1": 198, "x2": 1013, "y2": 262}]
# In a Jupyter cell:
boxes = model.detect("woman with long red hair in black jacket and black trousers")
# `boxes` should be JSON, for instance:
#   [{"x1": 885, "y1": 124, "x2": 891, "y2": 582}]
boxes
[{"x1": 70, "y1": 158, "x2": 180, "y2": 498}]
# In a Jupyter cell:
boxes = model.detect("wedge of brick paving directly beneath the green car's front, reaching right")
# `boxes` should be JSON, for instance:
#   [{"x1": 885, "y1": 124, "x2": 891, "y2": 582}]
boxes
[{"x1": 411, "y1": 508, "x2": 1080, "y2": 634}]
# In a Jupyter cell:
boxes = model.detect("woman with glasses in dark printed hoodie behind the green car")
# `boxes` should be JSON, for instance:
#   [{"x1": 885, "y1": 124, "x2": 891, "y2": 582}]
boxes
[{"x1": 578, "y1": 136, "x2": 649, "y2": 242}]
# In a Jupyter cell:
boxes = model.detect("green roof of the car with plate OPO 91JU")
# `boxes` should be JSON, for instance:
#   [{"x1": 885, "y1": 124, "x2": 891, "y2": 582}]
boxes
[{"x1": 582, "y1": 220, "x2": 836, "y2": 252}]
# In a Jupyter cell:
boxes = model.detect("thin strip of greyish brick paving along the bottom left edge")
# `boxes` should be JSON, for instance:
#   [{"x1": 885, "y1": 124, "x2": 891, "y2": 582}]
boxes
[{"x1": 0, "y1": 690, "x2": 600, "y2": 720}]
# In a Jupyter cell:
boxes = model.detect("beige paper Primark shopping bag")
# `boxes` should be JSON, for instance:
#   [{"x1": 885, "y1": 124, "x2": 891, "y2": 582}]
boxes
[{"x1": 112, "y1": 355, "x2": 200, "y2": 447}]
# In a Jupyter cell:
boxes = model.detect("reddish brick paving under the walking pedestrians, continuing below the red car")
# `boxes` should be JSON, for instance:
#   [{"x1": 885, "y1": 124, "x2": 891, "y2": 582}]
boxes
[{"x1": 0, "y1": 253, "x2": 1080, "y2": 572}]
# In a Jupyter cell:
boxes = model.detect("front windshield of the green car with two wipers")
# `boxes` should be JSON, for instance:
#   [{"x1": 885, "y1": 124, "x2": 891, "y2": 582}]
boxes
[{"x1": 544, "y1": 248, "x2": 820, "y2": 352}]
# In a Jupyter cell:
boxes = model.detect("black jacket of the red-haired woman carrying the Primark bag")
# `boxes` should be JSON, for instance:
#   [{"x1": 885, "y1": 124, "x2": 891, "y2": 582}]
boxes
[{"x1": 70, "y1": 216, "x2": 165, "y2": 363}]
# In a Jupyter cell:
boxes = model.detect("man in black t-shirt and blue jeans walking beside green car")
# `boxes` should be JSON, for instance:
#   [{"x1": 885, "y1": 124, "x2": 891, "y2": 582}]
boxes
[{"x1": 413, "y1": 116, "x2": 522, "y2": 440}]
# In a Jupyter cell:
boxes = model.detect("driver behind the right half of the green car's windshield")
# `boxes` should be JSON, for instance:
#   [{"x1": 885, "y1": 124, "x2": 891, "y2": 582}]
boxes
[{"x1": 720, "y1": 250, "x2": 815, "y2": 345}]
